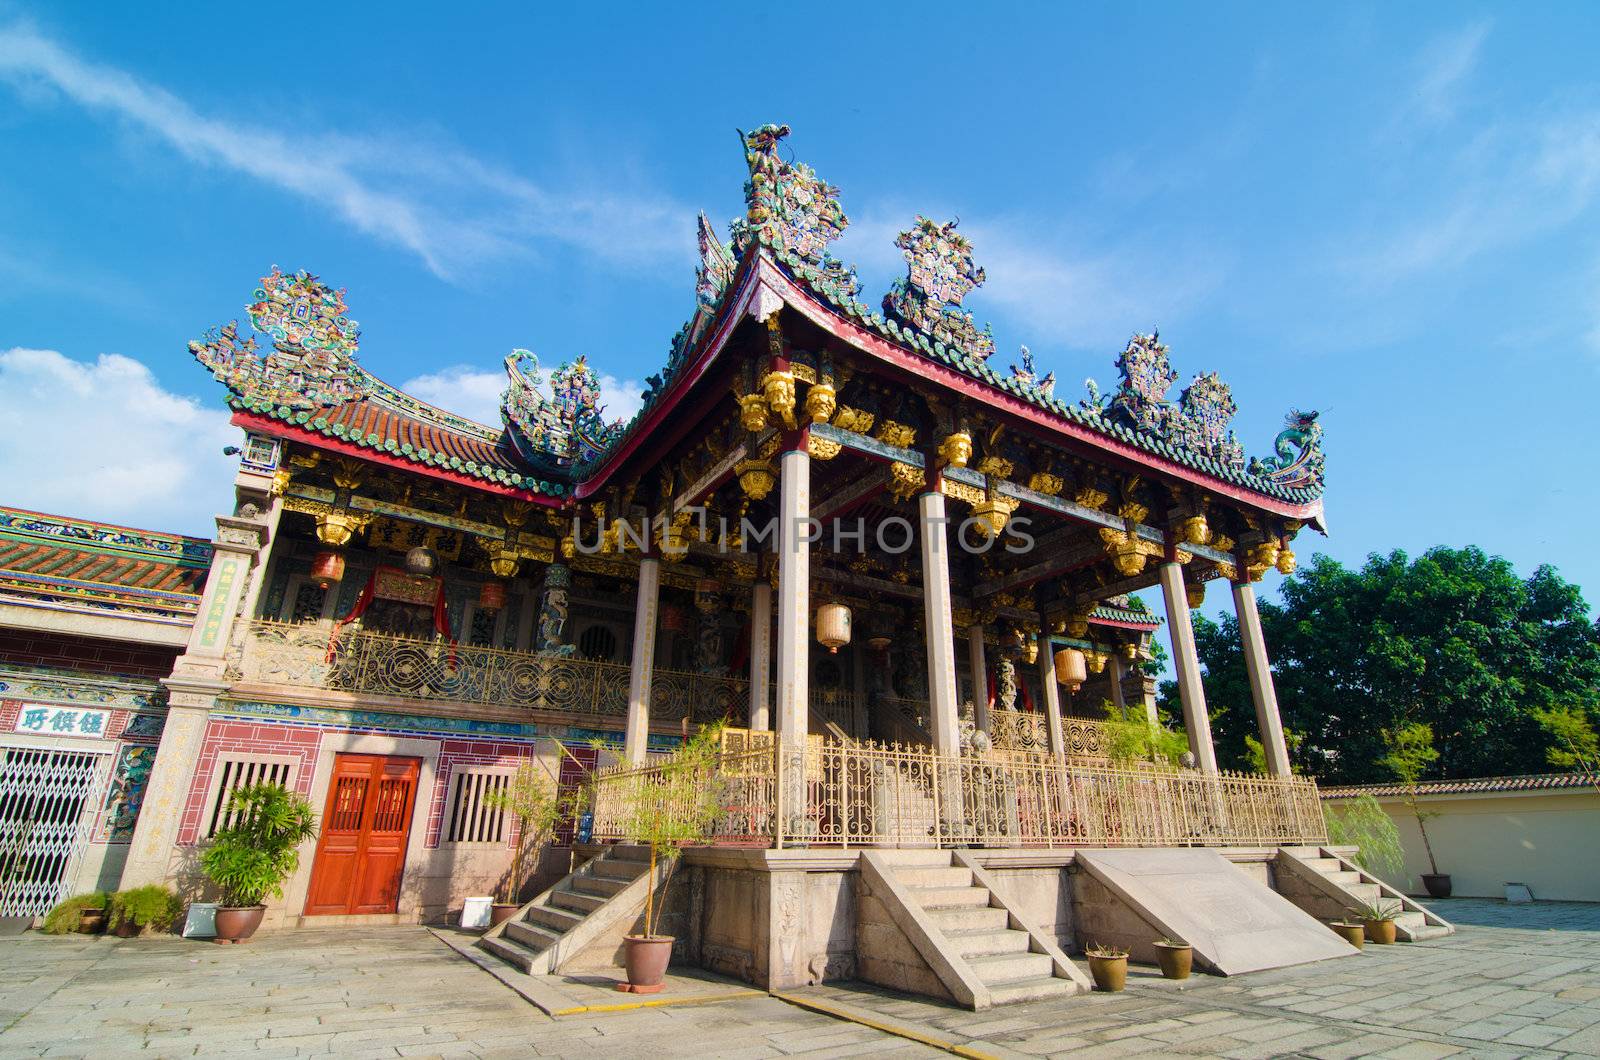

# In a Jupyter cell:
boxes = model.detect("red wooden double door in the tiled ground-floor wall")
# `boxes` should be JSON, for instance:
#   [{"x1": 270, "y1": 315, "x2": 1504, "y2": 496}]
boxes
[{"x1": 306, "y1": 754, "x2": 421, "y2": 916}]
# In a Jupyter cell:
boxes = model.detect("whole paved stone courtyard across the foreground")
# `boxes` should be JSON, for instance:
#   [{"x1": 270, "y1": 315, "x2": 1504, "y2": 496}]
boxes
[{"x1": 0, "y1": 900, "x2": 1600, "y2": 1060}]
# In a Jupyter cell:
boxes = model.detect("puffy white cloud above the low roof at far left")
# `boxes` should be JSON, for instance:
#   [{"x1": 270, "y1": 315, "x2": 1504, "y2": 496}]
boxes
[{"x1": 0, "y1": 347, "x2": 240, "y2": 536}]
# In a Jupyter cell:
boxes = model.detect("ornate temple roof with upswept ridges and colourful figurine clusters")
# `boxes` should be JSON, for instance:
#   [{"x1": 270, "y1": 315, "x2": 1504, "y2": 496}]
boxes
[{"x1": 190, "y1": 125, "x2": 1323, "y2": 519}]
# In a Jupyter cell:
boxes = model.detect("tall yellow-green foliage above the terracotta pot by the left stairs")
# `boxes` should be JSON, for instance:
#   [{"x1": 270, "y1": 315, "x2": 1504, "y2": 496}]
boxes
[{"x1": 622, "y1": 724, "x2": 725, "y2": 937}]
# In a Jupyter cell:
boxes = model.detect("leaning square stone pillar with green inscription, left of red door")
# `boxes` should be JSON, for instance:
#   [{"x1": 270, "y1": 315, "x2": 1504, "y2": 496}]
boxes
[{"x1": 122, "y1": 516, "x2": 270, "y2": 887}]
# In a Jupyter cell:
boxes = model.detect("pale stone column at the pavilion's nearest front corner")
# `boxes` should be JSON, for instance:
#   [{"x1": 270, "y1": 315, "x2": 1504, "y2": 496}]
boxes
[{"x1": 776, "y1": 436, "x2": 811, "y2": 836}]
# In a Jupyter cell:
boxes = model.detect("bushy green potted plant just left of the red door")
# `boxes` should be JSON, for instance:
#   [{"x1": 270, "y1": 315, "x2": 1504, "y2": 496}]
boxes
[{"x1": 200, "y1": 783, "x2": 317, "y2": 943}]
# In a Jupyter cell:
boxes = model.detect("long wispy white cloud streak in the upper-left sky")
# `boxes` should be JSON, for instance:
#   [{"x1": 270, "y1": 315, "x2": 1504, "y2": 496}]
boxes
[{"x1": 0, "y1": 26, "x2": 694, "y2": 279}]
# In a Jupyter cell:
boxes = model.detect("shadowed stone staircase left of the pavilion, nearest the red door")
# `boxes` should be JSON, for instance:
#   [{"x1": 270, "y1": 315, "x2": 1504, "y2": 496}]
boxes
[{"x1": 477, "y1": 845, "x2": 650, "y2": 975}]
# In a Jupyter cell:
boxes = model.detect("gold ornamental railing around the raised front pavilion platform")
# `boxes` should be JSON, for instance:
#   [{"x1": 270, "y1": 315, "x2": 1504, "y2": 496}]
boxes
[{"x1": 595, "y1": 738, "x2": 1326, "y2": 847}]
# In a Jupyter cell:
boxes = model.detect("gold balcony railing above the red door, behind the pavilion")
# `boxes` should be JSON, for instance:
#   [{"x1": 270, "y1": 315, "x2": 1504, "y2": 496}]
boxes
[{"x1": 240, "y1": 621, "x2": 749, "y2": 722}]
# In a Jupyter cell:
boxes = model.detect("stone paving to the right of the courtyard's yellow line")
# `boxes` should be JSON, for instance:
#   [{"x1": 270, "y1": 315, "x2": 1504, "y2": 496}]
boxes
[{"x1": 805, "y1": 898, "x2": 1600, "y2": 1060}]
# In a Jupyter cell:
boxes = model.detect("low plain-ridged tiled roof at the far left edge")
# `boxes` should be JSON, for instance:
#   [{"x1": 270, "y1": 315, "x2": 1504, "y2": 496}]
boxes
[{"x1": 0, "y1": 508, "x2": 211, "y2": 620}]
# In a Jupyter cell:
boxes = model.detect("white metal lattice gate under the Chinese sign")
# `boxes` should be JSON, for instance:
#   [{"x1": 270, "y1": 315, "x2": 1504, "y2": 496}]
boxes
[{"x1": 0, "y1": 746, "x2": 110, "y2": 916}]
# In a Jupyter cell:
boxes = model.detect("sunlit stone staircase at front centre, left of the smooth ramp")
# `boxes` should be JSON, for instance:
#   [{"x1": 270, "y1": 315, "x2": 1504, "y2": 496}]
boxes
[{"x1": 864, "y1": 850, "x2": 1090, "y2": 1009}]
